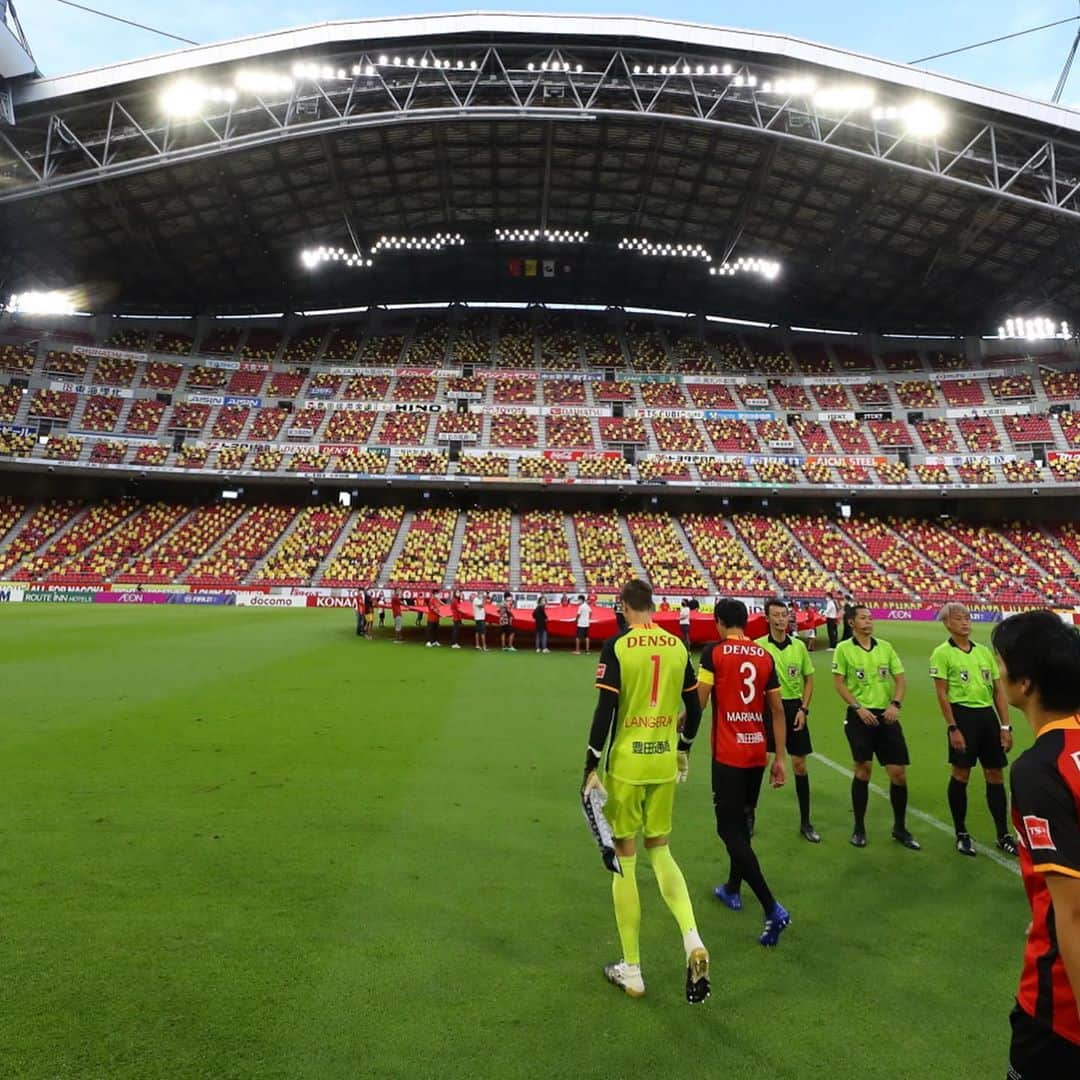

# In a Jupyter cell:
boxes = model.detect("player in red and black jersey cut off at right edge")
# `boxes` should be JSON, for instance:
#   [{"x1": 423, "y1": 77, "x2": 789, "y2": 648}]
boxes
[{"x1": 991, "y1": 611, "x2": 1080, "y2": 1080}]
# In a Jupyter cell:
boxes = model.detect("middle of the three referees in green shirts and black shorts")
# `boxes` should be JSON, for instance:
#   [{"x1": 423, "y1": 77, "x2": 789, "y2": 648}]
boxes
[{"x1": 833, "y1": 604, "x2": 920, "y2": 851}]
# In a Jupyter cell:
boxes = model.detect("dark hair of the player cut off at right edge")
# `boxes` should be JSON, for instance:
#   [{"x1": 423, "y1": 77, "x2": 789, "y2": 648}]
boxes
[{"x1": 990, "y1": 611, "x2": 1080, "y2": 713}]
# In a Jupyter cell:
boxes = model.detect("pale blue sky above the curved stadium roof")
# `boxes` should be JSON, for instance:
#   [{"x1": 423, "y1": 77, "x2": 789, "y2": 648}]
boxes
[{"x1": 15, "y1": 0, "x2": 1080, "y2": 108}]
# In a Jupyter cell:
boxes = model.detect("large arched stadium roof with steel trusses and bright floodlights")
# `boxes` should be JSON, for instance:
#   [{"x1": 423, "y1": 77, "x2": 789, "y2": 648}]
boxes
[{"x1": 0, "y1": 13, "x2": 1080, "y2": 333}]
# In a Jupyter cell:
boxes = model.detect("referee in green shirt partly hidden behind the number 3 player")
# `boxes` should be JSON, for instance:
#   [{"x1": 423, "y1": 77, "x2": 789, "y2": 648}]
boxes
[{"x1": 757, "y1": 597, "x2": 821, "y2": 843}]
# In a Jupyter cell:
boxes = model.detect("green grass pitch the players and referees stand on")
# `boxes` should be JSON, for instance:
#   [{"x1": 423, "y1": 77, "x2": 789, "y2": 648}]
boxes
[{"x1": 0, "y1": 606, "x2": 1030, "y2": 1080}]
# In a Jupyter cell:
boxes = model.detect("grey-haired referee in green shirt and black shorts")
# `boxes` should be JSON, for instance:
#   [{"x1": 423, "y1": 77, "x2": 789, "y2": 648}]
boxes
[{"x1": 930, "y1": 604, "x2": 1016, "y2": 855}]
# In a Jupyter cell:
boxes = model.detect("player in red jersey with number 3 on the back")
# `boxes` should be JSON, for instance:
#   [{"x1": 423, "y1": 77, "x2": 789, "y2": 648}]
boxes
[{"x1": 698, "y1": 599, "x2": 792, "y2": 946}]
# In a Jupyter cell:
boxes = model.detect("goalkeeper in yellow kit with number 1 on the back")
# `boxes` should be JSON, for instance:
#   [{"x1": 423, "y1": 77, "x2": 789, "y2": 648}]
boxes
[{"x1": 581, "y1": 581, "x2": 708, "y2": 1004}]
